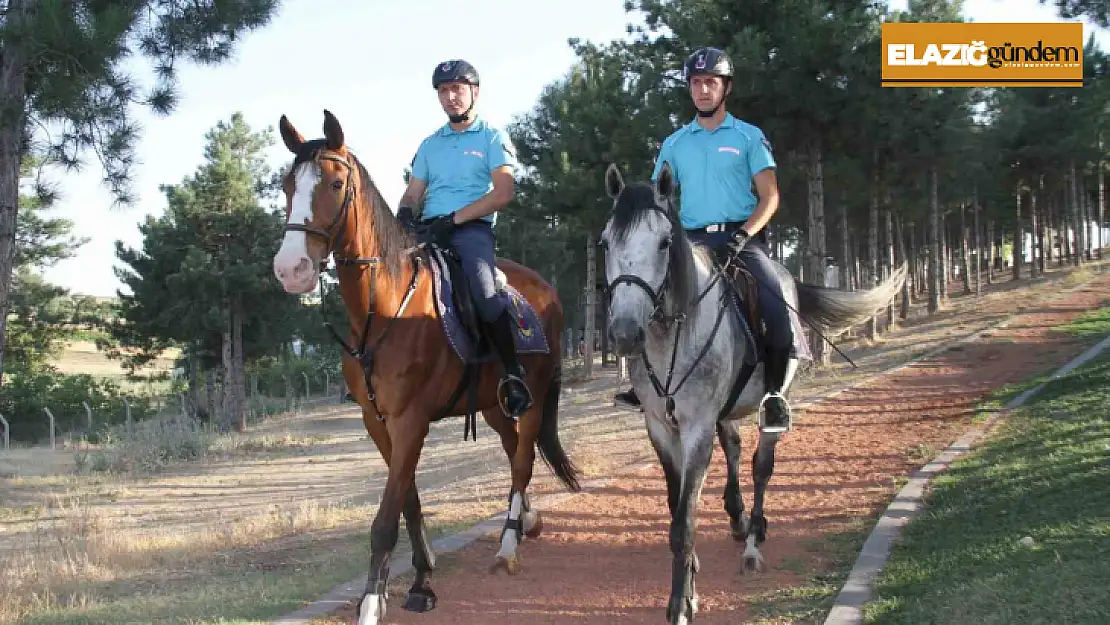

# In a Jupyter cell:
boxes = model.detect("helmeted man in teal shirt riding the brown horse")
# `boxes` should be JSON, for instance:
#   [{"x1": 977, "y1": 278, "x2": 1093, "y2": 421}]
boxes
[{"x1": 397, "y1": 59, "x2": 532, "y2": 421}]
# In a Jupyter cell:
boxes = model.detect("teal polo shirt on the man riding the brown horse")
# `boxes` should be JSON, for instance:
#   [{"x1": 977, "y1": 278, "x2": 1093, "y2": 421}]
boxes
[{"x1": 412, "y1": 118, "x2": 518, "y2": 223}]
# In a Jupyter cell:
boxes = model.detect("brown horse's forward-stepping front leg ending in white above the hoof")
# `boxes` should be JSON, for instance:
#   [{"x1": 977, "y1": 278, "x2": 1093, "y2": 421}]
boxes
[{"x1": 359, "y1": 414, "x2": 428, "y2": 625}]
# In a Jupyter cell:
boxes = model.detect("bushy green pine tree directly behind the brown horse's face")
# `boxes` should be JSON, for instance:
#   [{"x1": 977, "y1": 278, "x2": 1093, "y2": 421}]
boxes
[{"x1": 111, "y1": 113, "x2": 302, "y2": 369}]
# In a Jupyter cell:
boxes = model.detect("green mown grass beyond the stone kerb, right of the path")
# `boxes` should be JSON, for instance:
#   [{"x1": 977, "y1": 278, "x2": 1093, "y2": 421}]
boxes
[{"x1": 865, "y1": 308, "x2": 1110, "y2": 625}]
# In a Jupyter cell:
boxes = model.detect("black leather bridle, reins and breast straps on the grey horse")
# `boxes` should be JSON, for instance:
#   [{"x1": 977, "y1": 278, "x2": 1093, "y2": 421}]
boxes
[{"x1": 605, "y1": 206, "x2": 751, "y2": 425}]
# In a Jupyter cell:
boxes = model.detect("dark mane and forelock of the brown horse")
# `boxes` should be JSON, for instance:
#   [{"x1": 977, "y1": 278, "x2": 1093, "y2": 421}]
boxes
[{"x1": 292, "y1": 139, "x2": 414, "y2": 278}]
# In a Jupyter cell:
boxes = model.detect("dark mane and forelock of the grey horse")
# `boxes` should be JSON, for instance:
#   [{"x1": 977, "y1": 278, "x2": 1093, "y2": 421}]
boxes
[{"x1": 609, "y1": 182, "x2": 698, "y2": 314}]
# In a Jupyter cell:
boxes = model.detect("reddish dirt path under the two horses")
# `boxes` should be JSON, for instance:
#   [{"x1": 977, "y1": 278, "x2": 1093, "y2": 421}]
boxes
[{"x1": 315, "y1": 269, "x2": 1110, "y2": 625}]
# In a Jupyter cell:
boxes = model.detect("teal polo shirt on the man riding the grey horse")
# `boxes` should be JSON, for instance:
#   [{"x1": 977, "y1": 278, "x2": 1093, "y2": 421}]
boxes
[{"x1": 652, "y1": 114, "x2": 776, "y2": 229}]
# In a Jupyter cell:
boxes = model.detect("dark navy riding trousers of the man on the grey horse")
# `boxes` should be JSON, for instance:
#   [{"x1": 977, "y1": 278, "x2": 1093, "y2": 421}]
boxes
[{"x1": 686, "y1": 230, "x2": 794, "y2": 350}]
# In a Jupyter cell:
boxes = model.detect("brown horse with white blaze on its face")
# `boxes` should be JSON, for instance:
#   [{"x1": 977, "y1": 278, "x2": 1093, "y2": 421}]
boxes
[{"x1": 274, "y1": 110, "x2": 579, "y2": 625}]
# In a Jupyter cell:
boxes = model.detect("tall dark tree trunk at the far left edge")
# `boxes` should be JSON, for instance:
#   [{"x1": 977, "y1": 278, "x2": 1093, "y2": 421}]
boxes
[{"x1": 0, "y1": 0, "x2": 34, "y2": 385}]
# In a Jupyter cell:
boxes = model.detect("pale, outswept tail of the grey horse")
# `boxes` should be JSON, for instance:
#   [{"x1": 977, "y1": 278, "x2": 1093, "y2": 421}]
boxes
[{"x1": 795, "y1": 263, "x2": 907, "y2": 331}]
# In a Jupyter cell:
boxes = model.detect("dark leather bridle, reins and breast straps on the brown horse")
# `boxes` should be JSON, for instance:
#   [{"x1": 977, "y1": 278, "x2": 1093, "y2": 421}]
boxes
[{"x1": 285, "y1": 149, "x2": 421, "y2": 421}]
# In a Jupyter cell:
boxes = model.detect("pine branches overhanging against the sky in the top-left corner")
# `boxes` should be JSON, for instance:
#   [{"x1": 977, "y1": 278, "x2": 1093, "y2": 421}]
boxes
[{"x1": 10, "y1": 0, "x2": 278, "y2": 203}]
